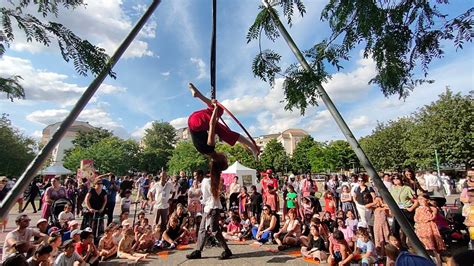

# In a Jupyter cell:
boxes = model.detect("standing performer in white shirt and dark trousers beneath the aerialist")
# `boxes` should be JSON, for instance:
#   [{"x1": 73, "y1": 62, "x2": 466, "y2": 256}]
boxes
[{"x1": 186, "y1": 170, "x2": 232, "y2": 259}]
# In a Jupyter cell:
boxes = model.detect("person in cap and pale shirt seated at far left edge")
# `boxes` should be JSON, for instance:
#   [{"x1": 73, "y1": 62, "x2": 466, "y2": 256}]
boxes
[{"x1": 2, "y1": 214, "x2": 48, "y2": 258}]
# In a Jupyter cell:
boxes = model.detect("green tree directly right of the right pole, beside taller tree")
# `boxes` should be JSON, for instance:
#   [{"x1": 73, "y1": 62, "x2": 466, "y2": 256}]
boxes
[{"x1": 360, "y1": 118, "x2": 415, "y2": 171}]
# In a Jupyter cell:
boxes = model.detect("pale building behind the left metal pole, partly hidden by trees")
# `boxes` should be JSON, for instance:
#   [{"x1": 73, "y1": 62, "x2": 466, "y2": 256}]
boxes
[{"x1": 40, "y1": 121, "x2": 95, "y2": 165}]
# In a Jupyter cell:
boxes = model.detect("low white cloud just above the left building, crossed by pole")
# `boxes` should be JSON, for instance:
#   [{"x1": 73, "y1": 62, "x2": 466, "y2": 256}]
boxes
[{"x1": 26, "y1": 108, "x2": 128, "y2": 138}]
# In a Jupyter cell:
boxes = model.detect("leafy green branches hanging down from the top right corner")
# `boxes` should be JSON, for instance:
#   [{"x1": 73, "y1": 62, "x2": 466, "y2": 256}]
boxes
[{"x1": 247, "y1": 0, "x2": 474, "y2": 113}]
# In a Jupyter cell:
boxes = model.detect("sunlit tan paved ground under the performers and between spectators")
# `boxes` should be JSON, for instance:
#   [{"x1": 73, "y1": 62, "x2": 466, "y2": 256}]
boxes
[{"x1": 0, "y1": 195, "x2": 459, "y2": 265}]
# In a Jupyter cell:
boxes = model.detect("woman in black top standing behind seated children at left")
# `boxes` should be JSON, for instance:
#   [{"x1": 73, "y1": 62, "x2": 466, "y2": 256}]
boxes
[{"x1": 83, "y1": 179, "x2": 107, "y2": 234}]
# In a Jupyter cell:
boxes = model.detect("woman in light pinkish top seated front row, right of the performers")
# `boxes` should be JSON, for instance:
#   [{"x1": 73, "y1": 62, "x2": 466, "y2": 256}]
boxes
[{"x1": 274, "y1": 208, "x2": 301, "y2": 251}]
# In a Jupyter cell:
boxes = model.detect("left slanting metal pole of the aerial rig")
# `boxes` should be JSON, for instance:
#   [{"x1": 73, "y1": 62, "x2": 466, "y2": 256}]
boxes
[{"x1": 0, "y1": 0, "x2": 161, "y2": 218}]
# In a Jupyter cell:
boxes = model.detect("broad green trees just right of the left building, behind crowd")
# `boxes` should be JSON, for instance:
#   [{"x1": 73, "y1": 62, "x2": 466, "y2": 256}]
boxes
[{"x1": 64, "y1": 136, "x2": 140, "y2": 175}]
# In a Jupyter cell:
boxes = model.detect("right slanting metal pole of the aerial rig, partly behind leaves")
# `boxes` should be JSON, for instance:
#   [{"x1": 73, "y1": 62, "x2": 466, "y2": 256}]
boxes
[{"x1": 262, "y1": 0, "x2": 431, "y2": 260}]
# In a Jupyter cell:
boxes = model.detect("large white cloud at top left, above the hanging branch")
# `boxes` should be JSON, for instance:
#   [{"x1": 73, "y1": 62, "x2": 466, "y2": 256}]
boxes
[{"x1": 0, "y1": 0, "x2": 157, "y2": 58}]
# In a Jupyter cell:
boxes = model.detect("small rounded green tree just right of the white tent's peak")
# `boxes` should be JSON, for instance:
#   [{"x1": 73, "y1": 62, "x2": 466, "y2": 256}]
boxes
[{"x1": 260, "y1": 139, "x2": 290, "y2": 172}]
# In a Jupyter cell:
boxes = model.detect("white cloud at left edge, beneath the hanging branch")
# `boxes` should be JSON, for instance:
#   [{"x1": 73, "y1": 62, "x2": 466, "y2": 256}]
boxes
[{"x1": 0, "y1": 56, "x2": 126, "y2": 107}]
